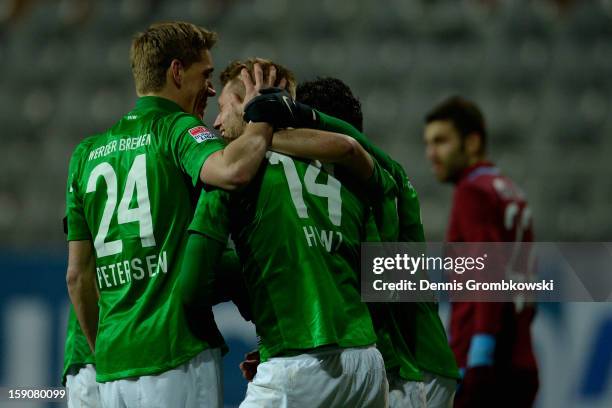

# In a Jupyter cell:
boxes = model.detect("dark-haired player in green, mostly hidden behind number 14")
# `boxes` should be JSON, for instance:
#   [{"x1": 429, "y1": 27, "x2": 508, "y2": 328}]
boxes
[{"x1": 297, "y1": 78, "x2": 458, "y2": 408}]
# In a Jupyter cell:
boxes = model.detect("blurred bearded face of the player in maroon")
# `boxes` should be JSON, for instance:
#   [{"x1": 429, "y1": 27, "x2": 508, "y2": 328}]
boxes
[{"x1": 424, "y1": 120, "x2": 468, "y2": 182}]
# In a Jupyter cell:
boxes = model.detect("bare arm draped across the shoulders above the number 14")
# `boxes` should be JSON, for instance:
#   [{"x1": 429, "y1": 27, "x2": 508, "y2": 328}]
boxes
[{"x1": 272, "y1": 129, "x2": 374, "y2": 181}]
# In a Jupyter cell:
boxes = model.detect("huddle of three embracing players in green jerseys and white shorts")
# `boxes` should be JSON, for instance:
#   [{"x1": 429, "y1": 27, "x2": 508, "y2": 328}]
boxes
[{"x1": 64, "y1": 22, "x2": 536, "y2": 407}]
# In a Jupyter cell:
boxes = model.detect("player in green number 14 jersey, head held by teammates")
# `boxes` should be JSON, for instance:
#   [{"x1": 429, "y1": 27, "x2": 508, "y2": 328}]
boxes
[{"x1": 183, "y1": 61, "x2": 387, "y2": 408}]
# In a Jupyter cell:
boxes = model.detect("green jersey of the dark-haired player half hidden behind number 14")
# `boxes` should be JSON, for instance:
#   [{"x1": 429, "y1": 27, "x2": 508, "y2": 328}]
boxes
[{"x1": 318, "y1": 112, "x2": 459, "y2": 380}]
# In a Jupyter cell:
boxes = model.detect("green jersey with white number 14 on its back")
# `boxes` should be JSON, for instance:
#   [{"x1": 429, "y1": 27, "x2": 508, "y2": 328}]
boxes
[{"x1": 190, "y1": 153, "x2": 376, "y2": 360}]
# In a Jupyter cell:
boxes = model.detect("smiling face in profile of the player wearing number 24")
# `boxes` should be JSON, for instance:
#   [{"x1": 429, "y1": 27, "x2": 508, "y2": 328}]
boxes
[{"x1": 181, "y1": 50, "x2": 216, "y2": 119}]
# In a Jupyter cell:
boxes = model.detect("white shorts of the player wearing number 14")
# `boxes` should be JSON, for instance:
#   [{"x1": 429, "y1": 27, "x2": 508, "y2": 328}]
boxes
[{"x1": 240, "y1": 346, "x2": 388, "y2": 408}]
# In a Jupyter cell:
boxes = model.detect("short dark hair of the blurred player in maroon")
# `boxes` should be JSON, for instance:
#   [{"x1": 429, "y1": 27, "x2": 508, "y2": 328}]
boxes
[{"x1": 425, "y1": 96, "x2": 487, "y2": 151}]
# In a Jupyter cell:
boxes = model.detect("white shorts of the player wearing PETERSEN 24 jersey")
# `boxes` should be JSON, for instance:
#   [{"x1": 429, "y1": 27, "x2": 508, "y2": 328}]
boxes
[{"x1": 100, "y1": 348, "x2": 223, "y2": 408}]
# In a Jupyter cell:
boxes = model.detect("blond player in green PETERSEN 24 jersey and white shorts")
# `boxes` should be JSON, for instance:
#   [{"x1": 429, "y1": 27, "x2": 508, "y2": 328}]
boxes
[{"x1": 66, "y1": 22, "x2": 288, "y2": 407}]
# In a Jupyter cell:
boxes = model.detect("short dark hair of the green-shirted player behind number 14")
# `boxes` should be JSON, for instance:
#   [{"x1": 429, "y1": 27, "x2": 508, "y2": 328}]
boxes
[{"x1": 296, "y1": 77, "x2": 363, "y2": 132}]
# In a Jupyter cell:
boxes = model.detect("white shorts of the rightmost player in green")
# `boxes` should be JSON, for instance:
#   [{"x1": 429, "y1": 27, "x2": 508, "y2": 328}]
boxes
[{"x1": 389, "y1": 372, "x2": 457, "y2": 408}]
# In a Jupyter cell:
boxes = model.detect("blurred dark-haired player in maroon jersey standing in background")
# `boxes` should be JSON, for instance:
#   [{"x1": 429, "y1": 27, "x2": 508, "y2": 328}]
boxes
[{"x1": 424, "y1": 97, "x2": 538, "y2": 408}]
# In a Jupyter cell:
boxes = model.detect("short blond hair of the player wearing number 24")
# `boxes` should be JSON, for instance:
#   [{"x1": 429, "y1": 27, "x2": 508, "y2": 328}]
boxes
[{"x1": 130, "y1": 21, "x2": 217, "y2": 95}]
